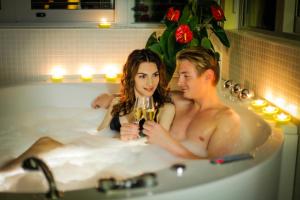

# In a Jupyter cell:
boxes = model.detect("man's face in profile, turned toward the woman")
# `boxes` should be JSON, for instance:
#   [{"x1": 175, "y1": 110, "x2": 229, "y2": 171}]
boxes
[{"x1": 178, "y1": 60, "x2": 207, "y2": 99}]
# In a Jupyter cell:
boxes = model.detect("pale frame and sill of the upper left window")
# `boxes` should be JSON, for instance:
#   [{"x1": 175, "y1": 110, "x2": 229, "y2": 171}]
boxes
[{"x1": 0, "y1": 0, "x2": 117, "y2": 27}]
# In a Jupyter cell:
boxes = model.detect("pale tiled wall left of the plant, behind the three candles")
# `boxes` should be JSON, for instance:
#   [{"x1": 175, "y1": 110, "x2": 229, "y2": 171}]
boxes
[{"x1": 0, "y1": 28, "x2": 162, "y2": 84}]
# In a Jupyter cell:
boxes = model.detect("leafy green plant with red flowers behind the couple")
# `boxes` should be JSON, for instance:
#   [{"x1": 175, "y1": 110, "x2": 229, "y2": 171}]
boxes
[{"x1": 146, "y1": 0, "x2": 230, "y2": 80}]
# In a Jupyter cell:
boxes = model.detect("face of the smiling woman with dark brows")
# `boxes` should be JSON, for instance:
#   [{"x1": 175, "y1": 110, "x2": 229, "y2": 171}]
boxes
[{"x1": 134, "y1": 62, "x2": 159, "y2": 97}]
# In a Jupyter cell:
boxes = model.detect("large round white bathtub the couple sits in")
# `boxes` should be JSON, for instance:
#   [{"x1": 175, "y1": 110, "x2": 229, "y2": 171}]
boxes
[{"x1": 0, "y1": 83, "x2": 283, "y2": 200}]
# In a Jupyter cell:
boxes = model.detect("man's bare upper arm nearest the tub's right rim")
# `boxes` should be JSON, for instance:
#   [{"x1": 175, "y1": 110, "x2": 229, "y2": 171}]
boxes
[{"x1": 207, "y1": 109, "x2": 240, "y2": 158}]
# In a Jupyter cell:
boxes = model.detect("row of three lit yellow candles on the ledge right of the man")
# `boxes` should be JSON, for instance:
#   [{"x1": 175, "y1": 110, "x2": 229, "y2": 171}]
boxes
[{"x1": 251, "y1": 99, "x2": 292, "y2": 124}]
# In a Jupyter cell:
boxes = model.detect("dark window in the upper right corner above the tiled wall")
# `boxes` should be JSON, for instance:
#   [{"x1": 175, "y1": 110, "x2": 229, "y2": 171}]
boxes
[{"x1": 240, "y1": 0, "x2": 300, "y2": 38}]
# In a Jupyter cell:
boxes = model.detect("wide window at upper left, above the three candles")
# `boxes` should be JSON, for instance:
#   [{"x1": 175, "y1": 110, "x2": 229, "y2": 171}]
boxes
[{"x1": 0, "y1": 0, "x2": 115, "y2": 24}]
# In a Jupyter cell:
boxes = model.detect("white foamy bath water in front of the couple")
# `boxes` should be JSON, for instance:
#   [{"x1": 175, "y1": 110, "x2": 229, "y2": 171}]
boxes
[{"x1": 0, "y1": 107, "x2": 180, "y2": 192}]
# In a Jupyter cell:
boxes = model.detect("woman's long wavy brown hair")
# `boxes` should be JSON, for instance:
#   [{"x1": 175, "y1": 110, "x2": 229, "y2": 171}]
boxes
[{"x1": 111, "y1": 49, "x2": 171, "y2": 116}]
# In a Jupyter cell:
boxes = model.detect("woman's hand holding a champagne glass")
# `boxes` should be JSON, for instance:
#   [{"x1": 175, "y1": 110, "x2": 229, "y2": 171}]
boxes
[{"x1": 120, "y1": 123, "x2": 139, "y2": 141}]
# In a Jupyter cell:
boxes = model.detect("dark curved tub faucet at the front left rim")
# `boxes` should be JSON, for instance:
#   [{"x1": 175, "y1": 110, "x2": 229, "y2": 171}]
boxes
[{"x1": 22, "y1": 157, "x2": 63, "y2": 199}]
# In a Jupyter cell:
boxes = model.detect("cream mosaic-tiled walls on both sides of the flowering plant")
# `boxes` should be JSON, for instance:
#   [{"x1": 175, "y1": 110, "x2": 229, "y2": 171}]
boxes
[{"x1": 0, "y1": 28, "x2": 300, "y2": 121}]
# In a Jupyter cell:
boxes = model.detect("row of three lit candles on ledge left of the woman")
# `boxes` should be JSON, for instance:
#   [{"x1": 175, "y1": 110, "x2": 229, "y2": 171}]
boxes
[{"x1": 51, "y1": 67, "x2": 118, "y2": 83}]
